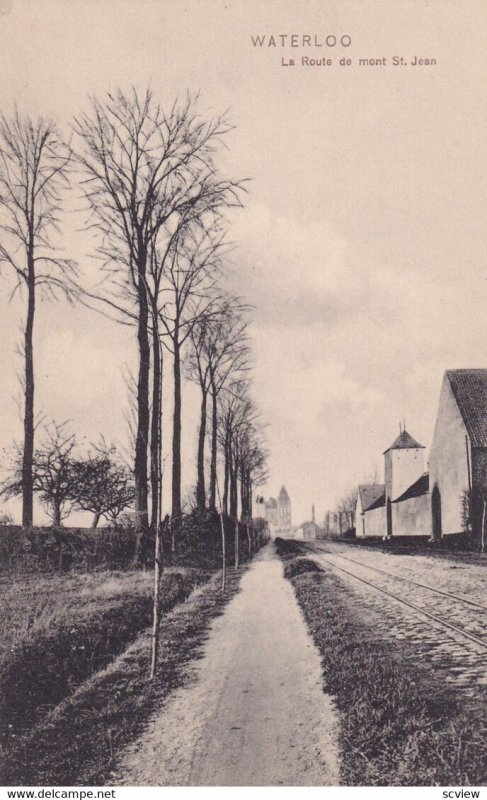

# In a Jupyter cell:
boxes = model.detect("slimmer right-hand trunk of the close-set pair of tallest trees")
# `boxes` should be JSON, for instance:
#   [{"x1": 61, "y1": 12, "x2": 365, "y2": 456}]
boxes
[{"x1": 150, "y1": 324, "x2": 163, "y2": 533}]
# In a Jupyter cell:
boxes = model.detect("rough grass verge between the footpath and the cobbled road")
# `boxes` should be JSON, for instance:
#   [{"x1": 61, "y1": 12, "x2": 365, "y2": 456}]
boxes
[{"x1": 280, "y1": 559, "x2": 487, "y2": 786}]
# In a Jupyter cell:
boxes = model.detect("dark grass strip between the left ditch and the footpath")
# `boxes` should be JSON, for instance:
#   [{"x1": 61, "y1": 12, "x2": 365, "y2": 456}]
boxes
[{"x1": 1, "y1": 572, "x2": 246, "y2": 786}]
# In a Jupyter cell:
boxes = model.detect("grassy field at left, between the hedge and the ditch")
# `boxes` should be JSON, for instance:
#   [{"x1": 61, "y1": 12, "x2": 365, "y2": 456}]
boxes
[{"x1": 0, "y1": 568, "x2": 209, "y2": 780}]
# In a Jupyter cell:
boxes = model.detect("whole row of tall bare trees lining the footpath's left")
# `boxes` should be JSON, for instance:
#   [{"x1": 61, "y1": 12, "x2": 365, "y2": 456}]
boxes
[{"x1": 0, "y1": 89, "x2": 265, "y2": 560}]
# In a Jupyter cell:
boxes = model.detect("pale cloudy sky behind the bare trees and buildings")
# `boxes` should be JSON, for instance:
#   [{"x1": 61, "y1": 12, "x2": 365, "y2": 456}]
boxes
[{"x1": 0, "y1": 0, "x2": 487, "y2": 524}]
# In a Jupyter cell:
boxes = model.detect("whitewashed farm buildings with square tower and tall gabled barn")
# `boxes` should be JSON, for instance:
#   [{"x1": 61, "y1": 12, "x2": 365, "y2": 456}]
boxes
[{"x1": 357, "y1": 369, "x2": 487, "y2": 540}]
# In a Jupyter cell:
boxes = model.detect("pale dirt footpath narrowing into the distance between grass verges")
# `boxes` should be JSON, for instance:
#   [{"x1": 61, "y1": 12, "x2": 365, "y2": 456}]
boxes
[{"x1": 113, "y1": 544, "x2": 338, "y2": 786}]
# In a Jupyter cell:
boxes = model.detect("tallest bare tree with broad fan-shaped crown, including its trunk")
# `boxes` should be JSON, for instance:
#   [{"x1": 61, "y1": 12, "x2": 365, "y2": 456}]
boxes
[{"x1": 75, "y1": 89, "x2": 241, "y2": 557}]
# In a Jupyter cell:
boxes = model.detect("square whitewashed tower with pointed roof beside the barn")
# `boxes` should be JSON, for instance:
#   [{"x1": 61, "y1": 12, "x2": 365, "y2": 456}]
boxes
[{"x1": 384, "y1": 428, "x2": 424, "y2": 537}]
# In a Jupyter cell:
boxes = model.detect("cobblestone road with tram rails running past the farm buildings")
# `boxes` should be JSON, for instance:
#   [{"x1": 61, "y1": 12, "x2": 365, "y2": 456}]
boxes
[{"x1": 310, "y1": 542, "x2": 487, "y2": 695}]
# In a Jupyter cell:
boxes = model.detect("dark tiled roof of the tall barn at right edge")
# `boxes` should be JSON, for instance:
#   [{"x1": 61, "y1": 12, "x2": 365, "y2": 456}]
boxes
[{"x1": 446, "y1": 369, "x2": 487, "y2": 447}]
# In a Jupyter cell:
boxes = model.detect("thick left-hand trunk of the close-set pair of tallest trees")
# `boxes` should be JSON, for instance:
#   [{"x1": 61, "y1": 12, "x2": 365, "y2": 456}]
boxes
[{"x1": 134, "y1": 251, "x2": 150, "y2": 564}]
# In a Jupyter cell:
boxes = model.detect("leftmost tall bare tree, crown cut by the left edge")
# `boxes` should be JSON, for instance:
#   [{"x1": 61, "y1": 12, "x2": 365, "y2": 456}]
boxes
[{"x1": 0, "y1": 110, "x2": 76, "y2": 528}]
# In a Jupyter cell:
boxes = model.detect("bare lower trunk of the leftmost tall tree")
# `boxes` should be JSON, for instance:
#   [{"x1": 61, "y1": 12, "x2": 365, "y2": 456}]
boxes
[{"x1": 22, "y1": 258, "x2": 35, "y2": 530}]
